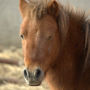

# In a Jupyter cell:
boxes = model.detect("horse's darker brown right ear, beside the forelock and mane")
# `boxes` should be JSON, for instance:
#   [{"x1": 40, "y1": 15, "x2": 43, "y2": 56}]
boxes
[{"x1": 47, "y1": 0, "x2": 59, "y2": 17}]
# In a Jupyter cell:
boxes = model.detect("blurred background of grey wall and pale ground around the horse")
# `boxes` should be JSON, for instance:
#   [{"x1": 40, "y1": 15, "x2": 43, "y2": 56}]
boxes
[{"x1": 0, "y1": 0, "x2": 90, "y2": 90}]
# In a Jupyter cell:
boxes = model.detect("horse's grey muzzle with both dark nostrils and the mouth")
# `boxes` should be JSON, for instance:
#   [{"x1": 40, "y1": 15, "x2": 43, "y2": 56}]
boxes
[{"x1": 24, "y1": 68, "x2": 44, "y2": 86}]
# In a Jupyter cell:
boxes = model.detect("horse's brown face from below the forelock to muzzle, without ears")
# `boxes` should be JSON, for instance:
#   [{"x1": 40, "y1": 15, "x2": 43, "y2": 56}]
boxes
[{"x1": 20, "y1": 0, "x2": 60, "y2": 86}]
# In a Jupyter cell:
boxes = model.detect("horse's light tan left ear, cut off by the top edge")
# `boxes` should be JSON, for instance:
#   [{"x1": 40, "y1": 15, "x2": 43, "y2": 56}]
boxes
[{"x1": 19, "y1": 0, "x2": 30, "y2": 18}]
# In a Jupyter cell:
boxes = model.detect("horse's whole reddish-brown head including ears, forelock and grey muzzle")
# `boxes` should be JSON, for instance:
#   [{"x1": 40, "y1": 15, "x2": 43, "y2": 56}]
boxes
[{"x1": 20, "y1": 0, "x2": 63, "y2": 85}]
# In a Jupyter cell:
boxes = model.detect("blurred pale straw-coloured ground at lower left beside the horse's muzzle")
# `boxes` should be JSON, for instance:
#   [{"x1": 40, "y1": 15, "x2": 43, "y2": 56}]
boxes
[{"x1": 0, "y1": 47, "x2": 49, "y2": 90}]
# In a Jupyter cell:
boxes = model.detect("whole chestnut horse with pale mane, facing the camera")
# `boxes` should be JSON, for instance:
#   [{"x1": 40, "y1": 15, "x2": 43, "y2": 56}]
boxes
[{"x1": 19, "y1": 0, "x2": 90, "y2": 90}]
